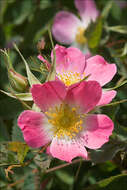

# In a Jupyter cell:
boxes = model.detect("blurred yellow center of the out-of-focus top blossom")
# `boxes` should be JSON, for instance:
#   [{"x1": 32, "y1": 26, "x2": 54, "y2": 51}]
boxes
[{"x1": 75, "y1": 27, "x2": 87, "y2": 45}]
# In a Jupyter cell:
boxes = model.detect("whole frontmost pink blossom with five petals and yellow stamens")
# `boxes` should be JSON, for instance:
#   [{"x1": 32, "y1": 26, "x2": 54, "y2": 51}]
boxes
[{"x1": 18, "y1": 81, "x2": 113, "y2": 162}]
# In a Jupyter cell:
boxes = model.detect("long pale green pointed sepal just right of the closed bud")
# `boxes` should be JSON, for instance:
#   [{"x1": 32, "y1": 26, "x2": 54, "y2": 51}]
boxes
[{"x1": 14, "y1": 44, "x2": 41, "y2": 86}]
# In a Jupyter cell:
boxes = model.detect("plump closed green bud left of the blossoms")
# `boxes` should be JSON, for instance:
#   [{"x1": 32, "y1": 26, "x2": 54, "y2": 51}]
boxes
[{"x1": 8, "y1": 69, "x2": 28, "y2": 92}]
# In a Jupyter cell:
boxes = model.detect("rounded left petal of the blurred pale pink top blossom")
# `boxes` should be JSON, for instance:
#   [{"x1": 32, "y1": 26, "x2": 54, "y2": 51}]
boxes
[{"x1": 52, "y1": 11, "x2": 81, "y2": 44}]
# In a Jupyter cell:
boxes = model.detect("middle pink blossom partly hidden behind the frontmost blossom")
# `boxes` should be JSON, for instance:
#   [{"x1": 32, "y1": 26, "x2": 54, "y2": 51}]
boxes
[{"x1": 38, "y1": 45, "x2": 117, "y2": 105}]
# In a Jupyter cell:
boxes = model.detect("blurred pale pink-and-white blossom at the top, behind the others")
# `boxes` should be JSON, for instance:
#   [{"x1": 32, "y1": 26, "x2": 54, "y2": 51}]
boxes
[{"x1": 52, "y1": 0, "x2": 99, "y2": 45}]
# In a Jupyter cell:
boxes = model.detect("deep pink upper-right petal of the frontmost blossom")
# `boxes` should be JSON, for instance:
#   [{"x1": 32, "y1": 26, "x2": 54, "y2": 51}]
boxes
[{"x1": 66, "y1": 81, "x2": 102, "y2": 113}]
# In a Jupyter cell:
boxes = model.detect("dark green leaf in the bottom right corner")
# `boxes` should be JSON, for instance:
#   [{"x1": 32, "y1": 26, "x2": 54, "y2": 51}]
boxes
[{"x1": 84, "y1": 174, "x2": 127, "y2": 190}]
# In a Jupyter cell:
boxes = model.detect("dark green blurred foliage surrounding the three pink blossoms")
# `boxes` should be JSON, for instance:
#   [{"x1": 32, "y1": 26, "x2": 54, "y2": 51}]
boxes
[{"x1": 0, "y1": 0, "x2": 127, "y2": 190}]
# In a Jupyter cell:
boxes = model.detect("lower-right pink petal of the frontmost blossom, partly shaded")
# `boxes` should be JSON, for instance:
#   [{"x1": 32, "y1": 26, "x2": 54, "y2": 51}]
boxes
[{"x1": 81, "y1": 114, "x2": 114, "y2": 149}]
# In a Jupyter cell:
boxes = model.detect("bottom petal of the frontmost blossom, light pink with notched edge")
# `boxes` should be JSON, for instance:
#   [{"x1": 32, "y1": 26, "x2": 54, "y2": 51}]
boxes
[{"x1": 50, "y1": 138, "x2": 87, "y2": 162}]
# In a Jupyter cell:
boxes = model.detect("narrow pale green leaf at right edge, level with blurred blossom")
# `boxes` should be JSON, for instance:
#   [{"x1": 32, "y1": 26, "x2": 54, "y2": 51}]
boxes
[{"x1": 105, "y1": 25, "x2": 127, "y2": 34}]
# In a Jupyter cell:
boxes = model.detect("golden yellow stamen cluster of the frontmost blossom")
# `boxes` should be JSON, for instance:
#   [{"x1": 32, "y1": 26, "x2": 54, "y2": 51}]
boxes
[{"x1": 45, "y1": 103, "x2": 83, "y2": 138}]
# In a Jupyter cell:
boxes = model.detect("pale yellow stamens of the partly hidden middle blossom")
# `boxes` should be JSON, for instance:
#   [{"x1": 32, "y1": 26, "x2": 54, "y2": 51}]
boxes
[{"x1": 57, "y1": 71, "x2": 83, "y2": 86}]
